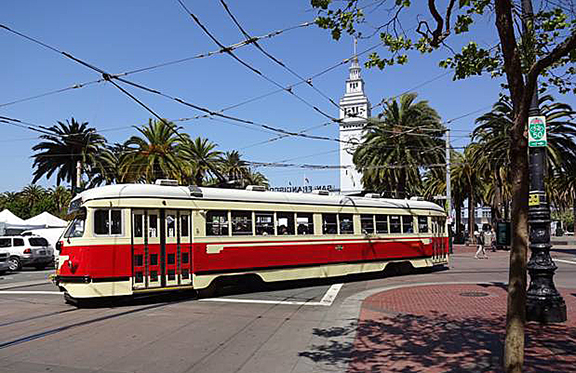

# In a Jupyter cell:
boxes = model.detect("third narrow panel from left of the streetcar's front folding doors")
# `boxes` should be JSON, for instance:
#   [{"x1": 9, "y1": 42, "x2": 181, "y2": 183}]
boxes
[{"x1": 161, "y1": 210, "x2": 180, "y2": 286}]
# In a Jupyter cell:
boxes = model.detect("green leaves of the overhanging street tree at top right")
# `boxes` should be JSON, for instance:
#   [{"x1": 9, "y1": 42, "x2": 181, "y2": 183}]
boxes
[{"x1": 311, "y1": 0, "x2": 576, "y2": 93}]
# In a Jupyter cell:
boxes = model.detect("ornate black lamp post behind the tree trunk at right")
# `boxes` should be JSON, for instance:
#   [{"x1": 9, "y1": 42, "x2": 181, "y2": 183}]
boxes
[{"x1": 522, "y1": 0, "x2": 566, "y2": 324}]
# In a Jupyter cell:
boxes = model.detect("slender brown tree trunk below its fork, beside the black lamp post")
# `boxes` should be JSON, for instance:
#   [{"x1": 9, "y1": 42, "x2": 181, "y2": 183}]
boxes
[{"x1": 504, "y1": 121, "x2": 529, "y2": 372}]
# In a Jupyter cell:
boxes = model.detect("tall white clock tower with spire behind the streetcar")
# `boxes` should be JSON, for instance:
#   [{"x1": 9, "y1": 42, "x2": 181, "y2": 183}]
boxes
[{"x1": 340, "y1": 42, "x2": 371, "y2": 193}]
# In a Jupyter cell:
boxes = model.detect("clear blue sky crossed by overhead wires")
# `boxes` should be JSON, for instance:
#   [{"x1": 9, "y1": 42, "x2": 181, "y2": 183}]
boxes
[{"x1": 0, "y1": 0, "x2": 576, "y2": 192}]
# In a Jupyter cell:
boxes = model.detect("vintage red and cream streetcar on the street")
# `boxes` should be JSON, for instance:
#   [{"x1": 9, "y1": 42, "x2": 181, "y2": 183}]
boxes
[{"x1": 55, "y1": 180, "x2": 449, "y2": 301}]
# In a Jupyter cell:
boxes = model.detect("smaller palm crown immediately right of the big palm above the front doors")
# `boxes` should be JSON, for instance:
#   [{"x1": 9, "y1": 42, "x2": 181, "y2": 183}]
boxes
[{"x1": 179, "y1": 137, "x2": 226, "y2": 186}]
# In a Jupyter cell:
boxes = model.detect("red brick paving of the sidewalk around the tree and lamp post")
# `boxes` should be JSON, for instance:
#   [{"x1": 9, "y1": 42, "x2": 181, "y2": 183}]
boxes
[{"x1": 349, "y1": 284, "x2": 576, "y2": 372}]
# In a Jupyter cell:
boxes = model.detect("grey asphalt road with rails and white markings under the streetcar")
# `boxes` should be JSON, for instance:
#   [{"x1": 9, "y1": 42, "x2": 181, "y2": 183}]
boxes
[{"x1": 0, "y1": 247, "x2": 576, "y2": 373}]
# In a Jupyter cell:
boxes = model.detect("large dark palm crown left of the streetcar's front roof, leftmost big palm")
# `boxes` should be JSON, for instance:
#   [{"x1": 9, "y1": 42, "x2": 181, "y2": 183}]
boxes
[{"x1": 32, "y1": 118, "x2": 106, "y2": 191}]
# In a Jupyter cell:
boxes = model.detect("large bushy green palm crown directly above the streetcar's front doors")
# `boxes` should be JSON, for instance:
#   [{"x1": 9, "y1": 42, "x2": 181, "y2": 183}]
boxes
[{"x1": 118, "y1": 119, "x2": 187, "y2": 183}]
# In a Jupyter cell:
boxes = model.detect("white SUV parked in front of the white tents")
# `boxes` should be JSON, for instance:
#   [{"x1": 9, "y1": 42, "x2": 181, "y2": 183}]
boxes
[{"x1": 0, "y1": 236, "x2": 54, "y2": 271}]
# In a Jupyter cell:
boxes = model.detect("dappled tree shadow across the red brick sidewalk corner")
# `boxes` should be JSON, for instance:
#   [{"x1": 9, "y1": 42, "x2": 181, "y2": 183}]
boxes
[{"x1": 299, "y1": 311, "x2": 576, "y2": 373}]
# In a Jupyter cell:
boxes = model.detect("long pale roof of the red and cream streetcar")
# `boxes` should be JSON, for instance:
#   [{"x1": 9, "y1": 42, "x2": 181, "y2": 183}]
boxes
[{"x1": 73, "y1": 184, "x2": 444, "y2": 213}]
